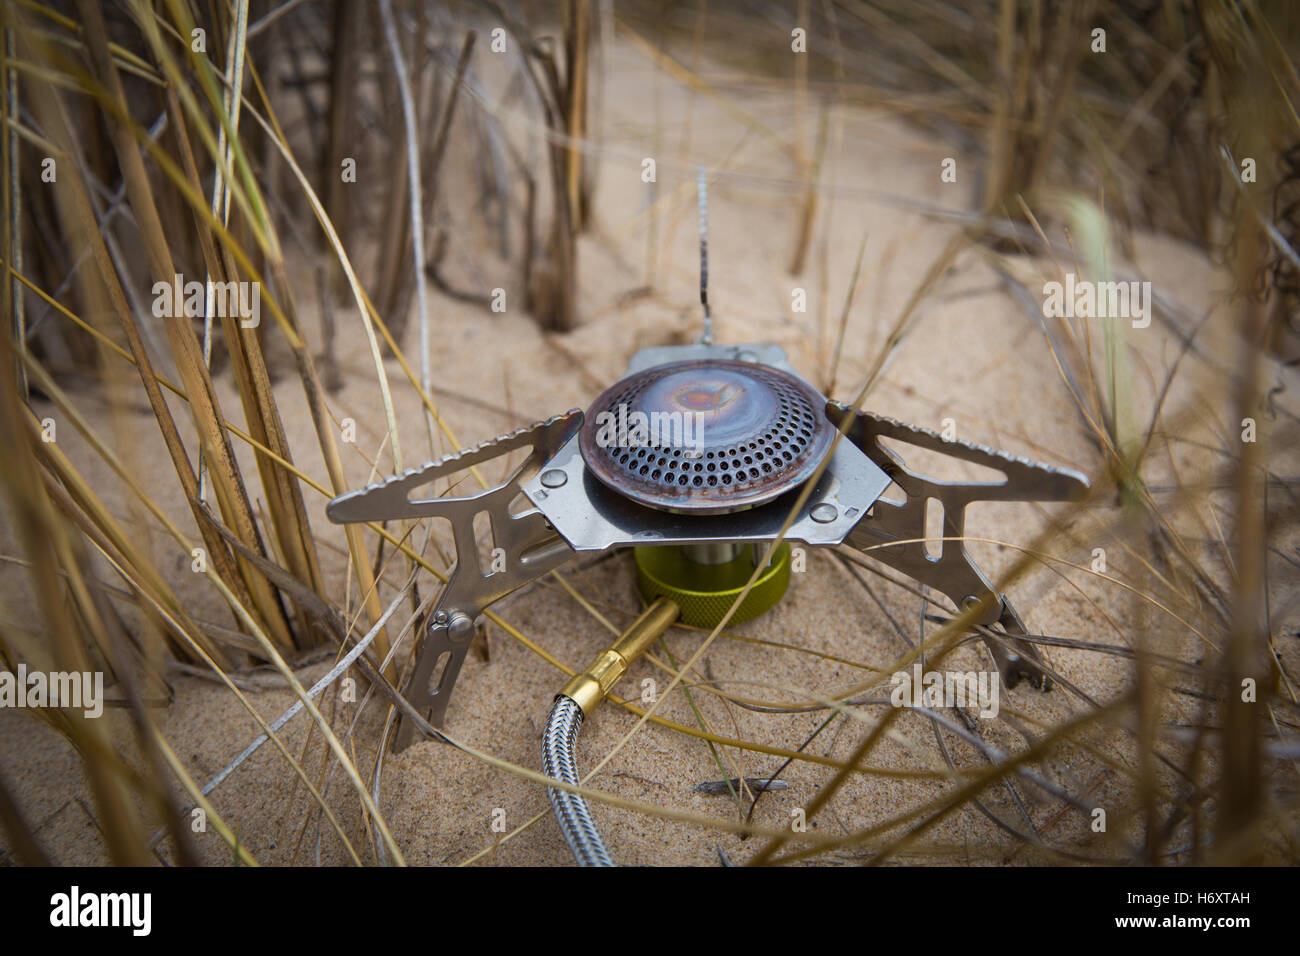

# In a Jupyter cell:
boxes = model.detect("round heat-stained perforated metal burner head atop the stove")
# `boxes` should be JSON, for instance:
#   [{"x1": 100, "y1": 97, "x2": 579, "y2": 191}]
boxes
[{"x1": 579, "y1": 359, "x2": 835, "y2": 514}]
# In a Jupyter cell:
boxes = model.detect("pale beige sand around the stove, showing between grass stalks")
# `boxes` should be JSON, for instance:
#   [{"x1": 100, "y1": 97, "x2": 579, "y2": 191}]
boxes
[{"x1": 0, "y1": 37, "x2": 1295, "y2": 865}]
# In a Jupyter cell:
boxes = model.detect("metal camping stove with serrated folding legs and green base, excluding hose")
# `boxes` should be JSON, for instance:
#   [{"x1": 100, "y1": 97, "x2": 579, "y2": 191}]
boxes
[{"x1": 326, "y1": 343, "x2": 1088, "y2": 749}]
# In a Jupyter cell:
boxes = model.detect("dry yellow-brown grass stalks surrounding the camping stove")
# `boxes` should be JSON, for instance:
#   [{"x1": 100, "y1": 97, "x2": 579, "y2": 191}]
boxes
[{"x1": 0, "y1": 0, "x2": 1300, "y2": 864}]
